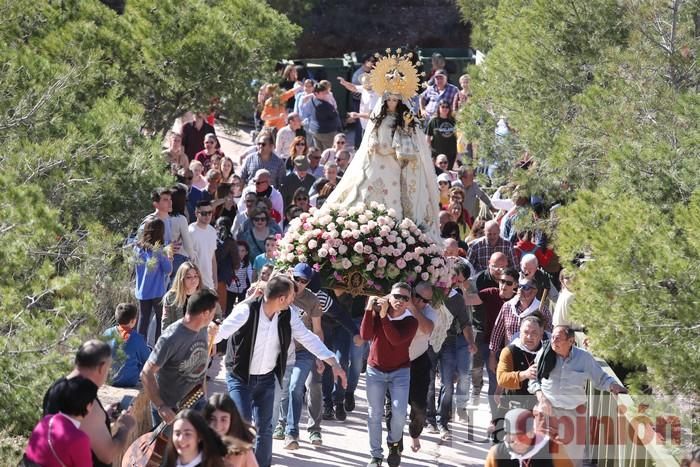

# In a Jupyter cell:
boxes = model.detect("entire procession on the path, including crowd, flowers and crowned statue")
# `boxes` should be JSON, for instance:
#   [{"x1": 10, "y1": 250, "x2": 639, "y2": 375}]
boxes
[{"x1": 8, "y1": 0, "x2": 700, "y2": 467}]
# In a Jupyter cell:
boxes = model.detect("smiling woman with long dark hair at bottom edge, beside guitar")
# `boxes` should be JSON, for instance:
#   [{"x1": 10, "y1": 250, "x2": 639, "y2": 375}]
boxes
[{"x1": 165, "y1": 409, "x2": 226, "y2": 467}]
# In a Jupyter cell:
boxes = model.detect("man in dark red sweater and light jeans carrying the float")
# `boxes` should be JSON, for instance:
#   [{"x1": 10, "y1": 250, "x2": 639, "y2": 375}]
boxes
[{"x1": 360, "y1": 282, "x2": 418, "y2": 467}]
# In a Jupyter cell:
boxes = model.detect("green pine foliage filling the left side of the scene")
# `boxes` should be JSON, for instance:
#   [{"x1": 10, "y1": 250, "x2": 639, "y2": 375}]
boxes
[{"x1": 0, "y1": 0, "x2": 297, "y2": 458}]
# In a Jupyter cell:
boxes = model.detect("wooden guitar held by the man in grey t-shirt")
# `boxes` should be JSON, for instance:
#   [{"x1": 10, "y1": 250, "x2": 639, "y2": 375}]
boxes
[{"x1": 122, "y1": 384, "x2": 204, "y2": 467}]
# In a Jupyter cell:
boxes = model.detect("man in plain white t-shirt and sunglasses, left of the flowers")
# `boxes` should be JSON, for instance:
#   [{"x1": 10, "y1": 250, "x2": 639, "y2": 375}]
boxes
[{"x1": 188, "y1": 201, "x2": 217, "y2": 290}]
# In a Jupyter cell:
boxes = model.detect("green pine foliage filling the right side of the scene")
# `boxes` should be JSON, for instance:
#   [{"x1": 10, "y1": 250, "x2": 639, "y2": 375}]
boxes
[{"x1": 460, "y1": 0, "x2": 700, "y2": 394}]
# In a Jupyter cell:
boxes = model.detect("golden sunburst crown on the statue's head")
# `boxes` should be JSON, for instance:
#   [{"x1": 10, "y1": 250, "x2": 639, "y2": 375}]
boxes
[{"x1": 369, "y1": 49, "x2": 420, "y2": 100}]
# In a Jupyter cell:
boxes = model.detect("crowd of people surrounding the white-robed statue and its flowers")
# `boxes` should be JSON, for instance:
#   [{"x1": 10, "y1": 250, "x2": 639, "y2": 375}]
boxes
[{"x1": 24, "y1": 51, "x2": 688, "y2": 467}]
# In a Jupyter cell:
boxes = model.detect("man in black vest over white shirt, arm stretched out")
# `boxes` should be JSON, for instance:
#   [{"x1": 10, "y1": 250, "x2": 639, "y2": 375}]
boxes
[{"x1": 215, "y1": 275, "x2": 347, "y2": 467}]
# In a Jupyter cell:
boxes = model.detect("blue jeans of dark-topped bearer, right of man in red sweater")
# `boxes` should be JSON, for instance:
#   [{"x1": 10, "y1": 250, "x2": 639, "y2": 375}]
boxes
[{"x1": 437, "y1": 336, "x2": 472, "y2": 428}]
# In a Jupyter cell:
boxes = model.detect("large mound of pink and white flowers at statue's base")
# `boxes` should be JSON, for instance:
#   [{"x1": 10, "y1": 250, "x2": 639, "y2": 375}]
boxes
[{"x1": 276, "y1": 202, "x2": 451, "y2": 296}]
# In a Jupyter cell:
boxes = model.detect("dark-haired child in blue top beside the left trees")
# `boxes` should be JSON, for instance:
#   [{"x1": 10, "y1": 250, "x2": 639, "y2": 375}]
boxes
[{"x1": 104, "y1": 303, "x2": 151, "y2": 388}]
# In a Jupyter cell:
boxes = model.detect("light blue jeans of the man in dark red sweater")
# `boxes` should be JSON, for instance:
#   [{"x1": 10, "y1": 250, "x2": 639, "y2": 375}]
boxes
[{"x1": 367, "y1": 366, "x2": 411, "y2": 457}]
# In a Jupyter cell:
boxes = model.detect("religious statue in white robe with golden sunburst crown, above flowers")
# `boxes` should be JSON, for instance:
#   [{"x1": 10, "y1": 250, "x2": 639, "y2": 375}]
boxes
[{"x1": 327, "y1": 51, "x2": 440, "y2": 242}]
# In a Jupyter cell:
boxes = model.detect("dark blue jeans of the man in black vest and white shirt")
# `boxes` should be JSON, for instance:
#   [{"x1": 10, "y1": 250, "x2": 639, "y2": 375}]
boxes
[{"x1": 226, "y1": 371, "x2": 277, "y2": 467}]
